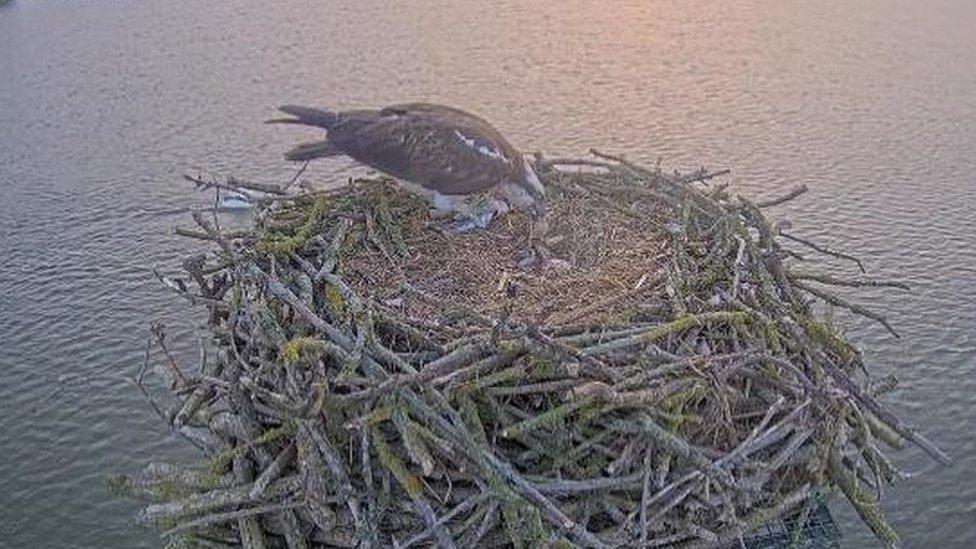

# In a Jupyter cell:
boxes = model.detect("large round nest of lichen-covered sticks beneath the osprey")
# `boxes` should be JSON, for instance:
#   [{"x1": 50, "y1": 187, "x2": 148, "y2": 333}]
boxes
[{"x1": 117, "y1": 150, "x2": 948, "y2": 547}]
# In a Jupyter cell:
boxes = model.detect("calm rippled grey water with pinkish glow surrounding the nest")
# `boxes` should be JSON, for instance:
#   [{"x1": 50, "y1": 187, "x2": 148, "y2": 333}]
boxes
[{"x1": 0, "y1": 0, "x2": 976, "y2": 548}]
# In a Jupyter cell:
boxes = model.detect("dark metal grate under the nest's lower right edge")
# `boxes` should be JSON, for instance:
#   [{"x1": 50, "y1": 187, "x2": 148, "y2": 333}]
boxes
[{"x1": 726, "y1": 502, "x2": 840, "y2": 549}]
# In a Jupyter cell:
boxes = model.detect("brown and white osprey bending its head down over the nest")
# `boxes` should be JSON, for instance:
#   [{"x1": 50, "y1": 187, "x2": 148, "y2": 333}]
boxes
[{"x1": 268, "y1": 103, "x2": 546, "y2": 232}]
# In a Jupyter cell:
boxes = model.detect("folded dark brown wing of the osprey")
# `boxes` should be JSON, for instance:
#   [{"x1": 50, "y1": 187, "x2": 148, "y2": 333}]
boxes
[{"x1": 329, "y1": 103, "x2": 523, "y2": 194}]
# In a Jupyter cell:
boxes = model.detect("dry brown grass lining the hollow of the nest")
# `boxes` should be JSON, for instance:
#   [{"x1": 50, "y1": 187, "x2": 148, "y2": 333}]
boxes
[{"x1": 342, "y1": 172, "x2": 665, "y2": 324}]
